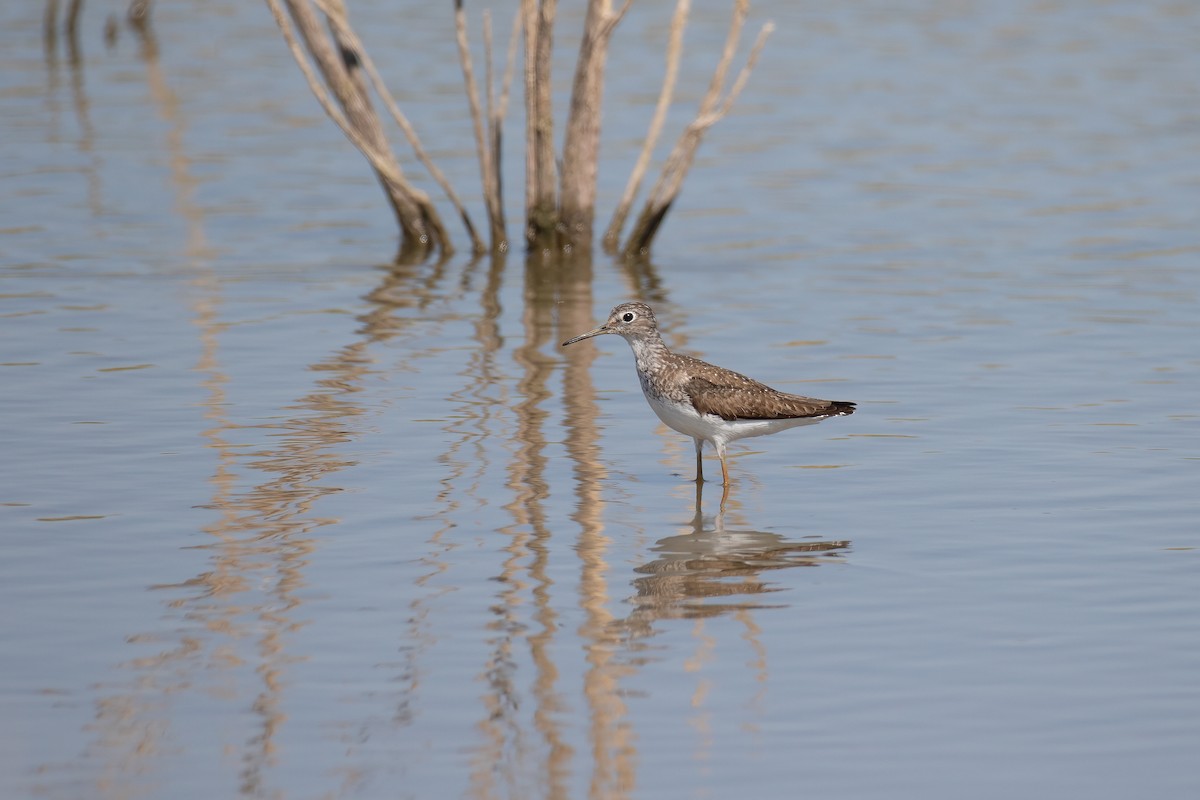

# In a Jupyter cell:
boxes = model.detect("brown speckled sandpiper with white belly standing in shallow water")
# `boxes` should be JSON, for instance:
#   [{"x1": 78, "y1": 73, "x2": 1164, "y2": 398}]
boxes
[{"x1": 563, "y1": 302, "x2": 854, "y2": 487}]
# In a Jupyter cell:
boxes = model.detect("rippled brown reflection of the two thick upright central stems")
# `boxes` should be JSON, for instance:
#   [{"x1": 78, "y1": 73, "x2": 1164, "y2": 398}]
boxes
[{"x1": 470, "y1": 253, "x2": 635, "y2": 798}]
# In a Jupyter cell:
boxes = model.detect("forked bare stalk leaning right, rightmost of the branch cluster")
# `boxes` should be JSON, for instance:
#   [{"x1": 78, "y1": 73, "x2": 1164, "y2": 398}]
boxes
[{"x1": 623, "y1": 0, "x2": 775, "y2": 255}]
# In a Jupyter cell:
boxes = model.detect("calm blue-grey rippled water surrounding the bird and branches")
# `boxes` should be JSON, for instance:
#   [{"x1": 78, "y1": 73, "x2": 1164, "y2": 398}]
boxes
[{"x1": 0, "y1": 2, "x2": 1200, "y2": 798}]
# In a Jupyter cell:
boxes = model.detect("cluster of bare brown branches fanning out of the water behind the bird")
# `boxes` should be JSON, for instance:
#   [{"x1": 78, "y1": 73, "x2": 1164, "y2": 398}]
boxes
[{"x1": 262, "y1": 0, "x2": 774, "y2": 260}]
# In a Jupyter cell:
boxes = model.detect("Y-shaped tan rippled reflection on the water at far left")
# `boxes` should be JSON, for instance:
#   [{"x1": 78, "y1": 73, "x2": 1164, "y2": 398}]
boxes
[{"x1": 80, "y1": 14, "x2": 420, "y2": 798}]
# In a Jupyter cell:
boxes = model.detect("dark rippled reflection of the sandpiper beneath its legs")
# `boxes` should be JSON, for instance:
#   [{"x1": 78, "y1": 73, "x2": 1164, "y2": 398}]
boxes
[{"x1": 626, "y1": 483, "x2": 850, "y2": 633}]
